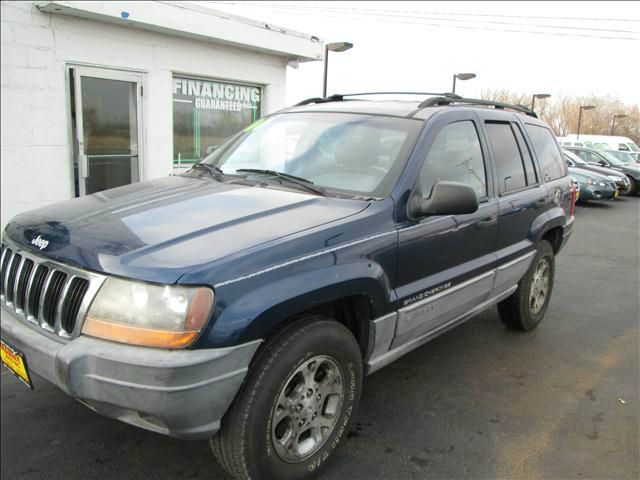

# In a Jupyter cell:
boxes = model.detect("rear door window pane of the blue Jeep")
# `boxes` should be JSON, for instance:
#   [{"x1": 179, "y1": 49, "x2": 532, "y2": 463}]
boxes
[{"x1": 486, "y1": 122, "x2": 527, "y2": 193}]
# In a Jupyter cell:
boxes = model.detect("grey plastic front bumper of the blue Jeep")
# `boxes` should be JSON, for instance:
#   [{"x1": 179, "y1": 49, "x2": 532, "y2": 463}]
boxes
[{"x1": 0, "y1": 306, "x2": 261, "y2": 440}]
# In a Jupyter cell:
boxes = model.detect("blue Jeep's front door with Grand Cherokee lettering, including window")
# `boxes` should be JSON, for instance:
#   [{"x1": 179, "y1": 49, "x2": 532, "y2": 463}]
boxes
[{"x1": 392, "y1": 112, "x2": 498, "y2": 348}]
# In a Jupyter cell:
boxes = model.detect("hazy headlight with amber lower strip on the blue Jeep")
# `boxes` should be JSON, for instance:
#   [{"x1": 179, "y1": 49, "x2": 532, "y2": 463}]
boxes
[{"x1": 82, "y1": 277, "x2": 213, "y2": 348}]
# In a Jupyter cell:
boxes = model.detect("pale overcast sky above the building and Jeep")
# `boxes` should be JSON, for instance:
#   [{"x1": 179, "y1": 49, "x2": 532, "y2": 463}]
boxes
[{"x1": 207, "y1": 0, "x2": 640, "y2": 104}]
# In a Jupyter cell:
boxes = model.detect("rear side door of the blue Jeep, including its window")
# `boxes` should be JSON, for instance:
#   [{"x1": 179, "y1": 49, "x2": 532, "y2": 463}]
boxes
[{"x1": 478, "y1": 111, "x2": 553, "y2": 270}]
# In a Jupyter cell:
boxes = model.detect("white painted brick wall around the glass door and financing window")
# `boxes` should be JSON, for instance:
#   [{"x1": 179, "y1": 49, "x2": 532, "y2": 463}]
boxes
[{"x1": 0, "y1": 1, "x2": 286, "y2": 227}]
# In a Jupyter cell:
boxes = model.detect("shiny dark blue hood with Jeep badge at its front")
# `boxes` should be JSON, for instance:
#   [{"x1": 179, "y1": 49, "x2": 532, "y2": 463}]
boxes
[{"x1": 6, "y1": 176, "x2": 369, "y2": 283}]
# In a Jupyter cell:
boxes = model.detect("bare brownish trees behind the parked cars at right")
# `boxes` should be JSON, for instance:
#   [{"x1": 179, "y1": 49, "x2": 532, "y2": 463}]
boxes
[{"x1": 480, "y1": 89, "x2": 640, "y2": 145}]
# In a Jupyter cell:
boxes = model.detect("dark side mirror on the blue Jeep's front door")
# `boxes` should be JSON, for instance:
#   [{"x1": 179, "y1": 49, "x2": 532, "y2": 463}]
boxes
[{"x1": 409, "y1": 181, "x2": 478, "y2": 218}]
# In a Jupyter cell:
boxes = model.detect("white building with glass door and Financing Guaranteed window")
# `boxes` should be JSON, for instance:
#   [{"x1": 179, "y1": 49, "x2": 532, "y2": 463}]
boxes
[{"x1": 1, "y1": 1, "x2": 322, "y2": 226}]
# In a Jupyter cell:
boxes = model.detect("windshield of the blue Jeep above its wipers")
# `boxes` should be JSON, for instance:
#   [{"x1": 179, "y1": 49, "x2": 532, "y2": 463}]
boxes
[{"x1": 203, "y1": 112, "x2": 422, "y2": 198}]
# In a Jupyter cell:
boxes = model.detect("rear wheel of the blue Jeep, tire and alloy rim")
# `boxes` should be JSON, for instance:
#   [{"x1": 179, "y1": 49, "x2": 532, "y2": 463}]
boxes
[{"x1": 498, "y1": 240, "x2": 555, "y2": 332}]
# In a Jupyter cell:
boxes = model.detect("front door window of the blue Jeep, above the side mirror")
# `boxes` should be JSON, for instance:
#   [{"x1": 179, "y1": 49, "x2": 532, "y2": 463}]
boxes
[{"x1": 420, "y1": 120, "x2": 487, "y2": 198}]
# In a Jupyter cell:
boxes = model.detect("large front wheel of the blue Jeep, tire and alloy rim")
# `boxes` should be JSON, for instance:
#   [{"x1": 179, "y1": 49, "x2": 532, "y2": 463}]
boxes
[{"x1": 210, "y1": 316, "x2": 363, "y2": 480}]
